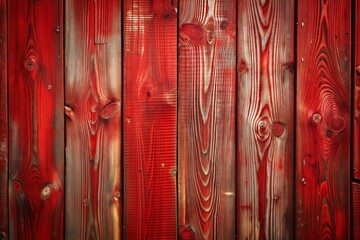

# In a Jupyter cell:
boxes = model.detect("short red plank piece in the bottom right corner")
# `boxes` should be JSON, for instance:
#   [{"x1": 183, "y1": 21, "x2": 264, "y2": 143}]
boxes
[{"x1": 351, "y1": 183, "x2": 360, "y2": 239}]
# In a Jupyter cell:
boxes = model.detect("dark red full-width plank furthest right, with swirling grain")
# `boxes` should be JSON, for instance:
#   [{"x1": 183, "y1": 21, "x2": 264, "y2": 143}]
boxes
[{"x1": 295, "y1": 0, "x2": 351, "y2": 239}]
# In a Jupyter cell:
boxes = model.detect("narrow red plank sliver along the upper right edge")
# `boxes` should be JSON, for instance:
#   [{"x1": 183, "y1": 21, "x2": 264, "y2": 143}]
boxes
[{"x1": 352, "y1": 0, "x2": 360, "y2": 179}]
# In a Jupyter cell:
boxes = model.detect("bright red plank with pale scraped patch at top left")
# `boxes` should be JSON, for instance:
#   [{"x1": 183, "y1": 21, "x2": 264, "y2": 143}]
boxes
[{"x1": 123, "y1": 0, "x2": 177, "y2": 239}]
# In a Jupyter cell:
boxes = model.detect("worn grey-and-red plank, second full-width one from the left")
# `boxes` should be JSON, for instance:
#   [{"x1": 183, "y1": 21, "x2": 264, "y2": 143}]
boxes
[{"x1": 65, "y1": 0, "x2": 122, "y2": 239}]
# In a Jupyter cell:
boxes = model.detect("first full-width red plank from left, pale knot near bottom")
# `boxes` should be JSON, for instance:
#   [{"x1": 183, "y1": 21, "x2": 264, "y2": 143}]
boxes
[{"x1": 7, "y1": 0, "x2": 64, "y2": 239}]
